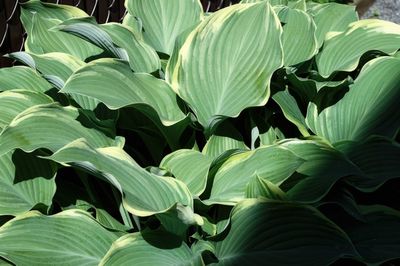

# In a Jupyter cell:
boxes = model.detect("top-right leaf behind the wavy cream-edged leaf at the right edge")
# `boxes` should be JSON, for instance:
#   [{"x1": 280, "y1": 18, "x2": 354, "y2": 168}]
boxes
[{"x1": 307, "y1": 3, "x2": 358, "y2": 48}]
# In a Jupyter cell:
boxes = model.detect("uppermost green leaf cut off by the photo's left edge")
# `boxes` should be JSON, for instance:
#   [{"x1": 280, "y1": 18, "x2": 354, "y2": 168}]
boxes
[{"x1": 0, "y1": 66, "x2": 52, "y2": 92}]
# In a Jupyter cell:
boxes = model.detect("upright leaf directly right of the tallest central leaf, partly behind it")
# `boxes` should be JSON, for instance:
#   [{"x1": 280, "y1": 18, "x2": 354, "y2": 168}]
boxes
[{"x1": 274, "y1": 7, "x2": 318, "y2": 66}]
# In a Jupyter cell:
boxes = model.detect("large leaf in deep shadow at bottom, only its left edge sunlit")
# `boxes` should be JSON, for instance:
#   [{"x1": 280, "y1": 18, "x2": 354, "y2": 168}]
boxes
[{"x1": 215, "y1": 199, "x2": 355, "y2": 266}]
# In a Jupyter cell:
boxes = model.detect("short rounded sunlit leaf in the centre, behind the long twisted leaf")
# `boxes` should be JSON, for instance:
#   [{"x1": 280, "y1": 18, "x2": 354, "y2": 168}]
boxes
[{"x1": 160, "y1": 149, "x2": 212, "y2": 196}]
